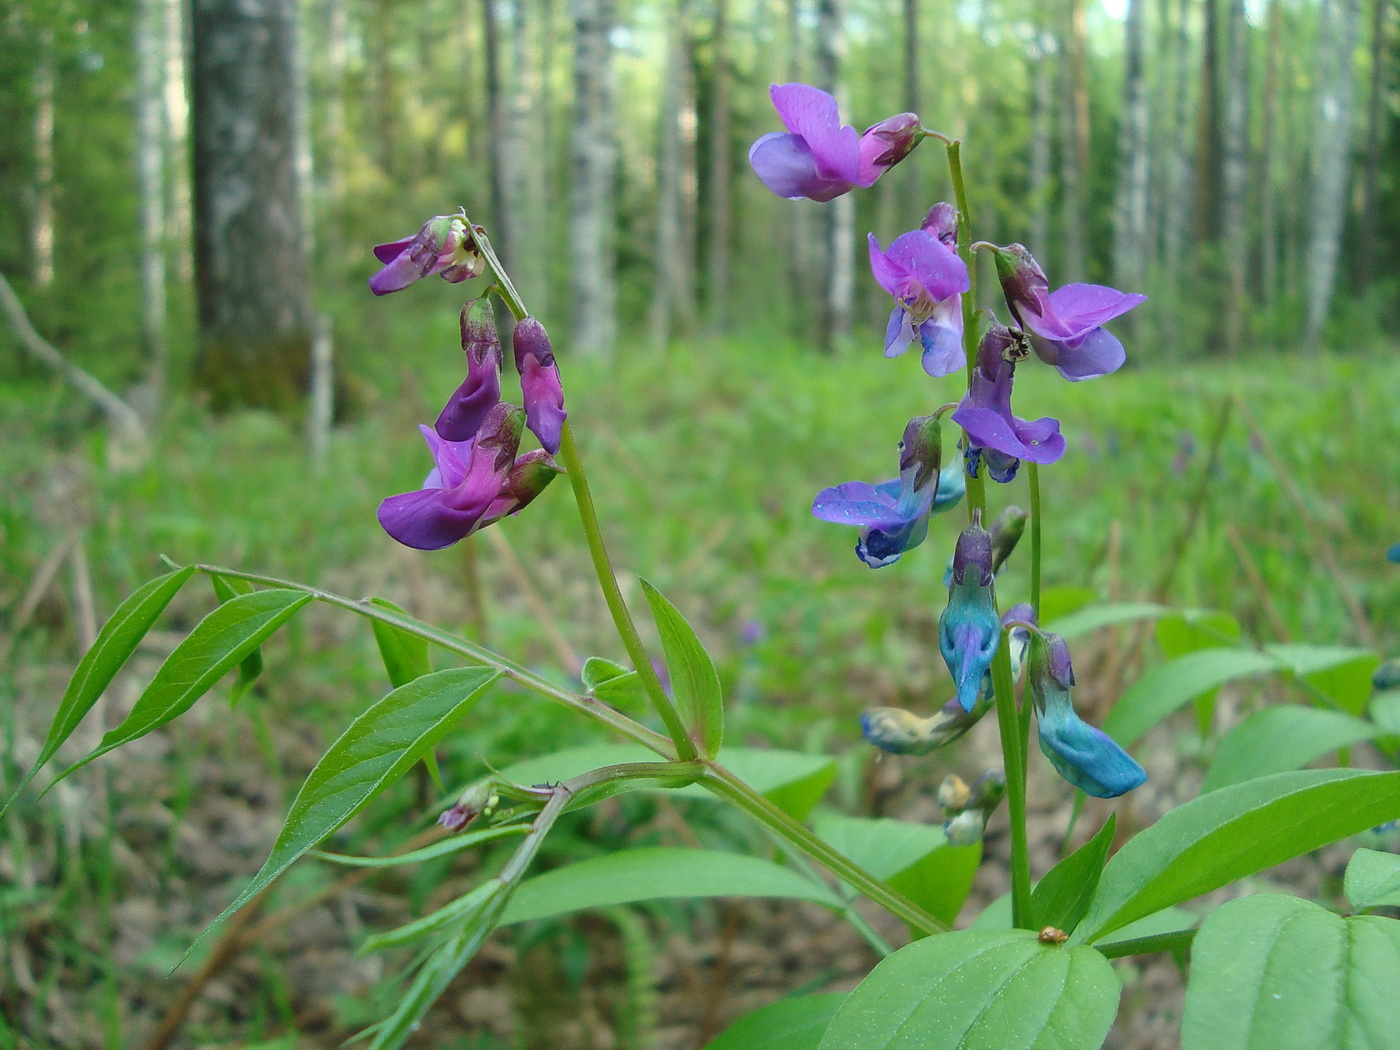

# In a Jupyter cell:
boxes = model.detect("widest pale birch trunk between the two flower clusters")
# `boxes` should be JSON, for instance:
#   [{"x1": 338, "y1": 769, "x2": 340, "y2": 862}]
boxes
[{"x1": 570, "y1": 0, "x2": 617, "y2": 354}]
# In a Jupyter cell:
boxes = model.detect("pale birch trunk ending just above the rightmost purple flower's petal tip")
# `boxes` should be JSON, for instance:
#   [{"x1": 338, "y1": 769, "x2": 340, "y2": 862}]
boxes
[{"x1": 1113, "y1": 0, "x2": 1148, "y2": 303}]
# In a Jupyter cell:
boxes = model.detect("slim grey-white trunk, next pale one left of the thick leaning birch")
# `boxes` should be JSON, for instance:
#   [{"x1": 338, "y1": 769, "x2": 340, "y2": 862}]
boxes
[{"x1": 1219, "y1": 0, "x2": 1249, "y2": 354}]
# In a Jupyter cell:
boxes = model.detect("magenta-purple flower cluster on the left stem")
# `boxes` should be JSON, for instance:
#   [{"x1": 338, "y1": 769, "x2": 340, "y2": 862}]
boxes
[{"x1": 370, "y1": 216, "x2": 567, "y2": 550}]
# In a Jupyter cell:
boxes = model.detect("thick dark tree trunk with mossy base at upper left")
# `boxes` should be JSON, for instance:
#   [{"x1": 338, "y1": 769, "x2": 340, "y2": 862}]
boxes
[{"x1": 192, "y1": 0, "x2": 311, "y2": 410}]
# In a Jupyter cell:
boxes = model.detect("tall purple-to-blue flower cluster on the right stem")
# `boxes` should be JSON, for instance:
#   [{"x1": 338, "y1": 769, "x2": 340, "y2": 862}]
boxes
[{"x1": 749, "y1": 84, "x2": 1145, "y2": 800}]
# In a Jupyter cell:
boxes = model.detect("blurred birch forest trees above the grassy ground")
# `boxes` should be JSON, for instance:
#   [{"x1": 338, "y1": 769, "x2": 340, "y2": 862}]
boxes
[{"x1": 0, "y1": 0, "x2": 1400, "y2": 406}]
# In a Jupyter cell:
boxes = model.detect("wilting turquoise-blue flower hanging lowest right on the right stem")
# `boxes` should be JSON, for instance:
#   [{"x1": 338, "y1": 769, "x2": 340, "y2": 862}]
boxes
[{"x1": 1028, "y1": 634, "x2": 1147, "y2": 798}]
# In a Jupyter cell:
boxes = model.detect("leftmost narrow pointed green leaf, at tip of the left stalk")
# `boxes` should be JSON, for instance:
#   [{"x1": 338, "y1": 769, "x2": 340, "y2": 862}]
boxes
[{"x1": 0, "y1": 566, "x2": 195, "y2": 813}]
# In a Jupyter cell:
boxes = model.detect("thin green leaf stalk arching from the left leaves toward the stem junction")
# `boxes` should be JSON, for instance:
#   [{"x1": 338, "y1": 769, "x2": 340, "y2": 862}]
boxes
[{"x1": 196, "y1": 566, "x2": 675, "y2": 759}]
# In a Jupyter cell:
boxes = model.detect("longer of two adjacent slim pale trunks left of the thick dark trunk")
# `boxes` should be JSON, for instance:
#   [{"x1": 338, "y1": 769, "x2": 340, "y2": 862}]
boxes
[{"x1": 136, "y1": 0, "x2": 169, "y2": 413}]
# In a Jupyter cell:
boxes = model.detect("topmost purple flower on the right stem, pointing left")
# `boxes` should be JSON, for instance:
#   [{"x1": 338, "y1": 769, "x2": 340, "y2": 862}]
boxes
[{"x1": 749, "y1": 84, "x2": 924, "y2": 200}]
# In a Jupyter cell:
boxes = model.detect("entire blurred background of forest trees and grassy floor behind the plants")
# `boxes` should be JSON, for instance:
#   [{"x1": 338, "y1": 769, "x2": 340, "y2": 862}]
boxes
[{"x1": 0, "y1": 0, "x2": 1400, "y2": 1050}]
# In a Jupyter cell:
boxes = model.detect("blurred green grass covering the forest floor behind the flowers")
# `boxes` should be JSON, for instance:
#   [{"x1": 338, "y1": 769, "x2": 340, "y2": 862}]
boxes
[{"x1": 0, "y1": 324, "x2": 1400, "y2": 1046}]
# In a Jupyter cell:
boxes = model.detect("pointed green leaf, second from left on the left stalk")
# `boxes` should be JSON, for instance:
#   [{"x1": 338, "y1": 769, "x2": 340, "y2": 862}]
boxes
[{"x1": 55, "y1": 589, "x2": 311, "y2": 783}]
